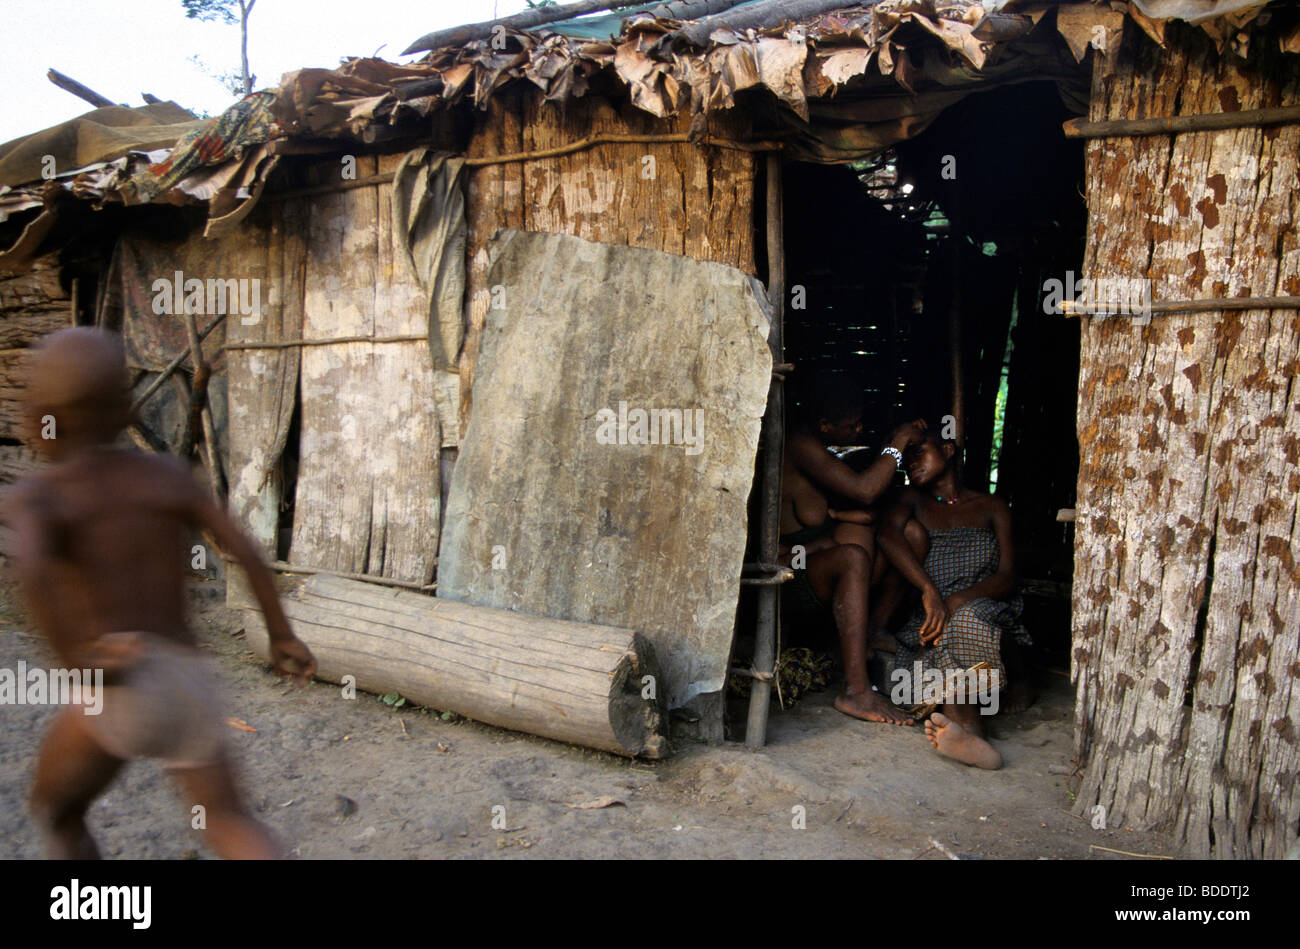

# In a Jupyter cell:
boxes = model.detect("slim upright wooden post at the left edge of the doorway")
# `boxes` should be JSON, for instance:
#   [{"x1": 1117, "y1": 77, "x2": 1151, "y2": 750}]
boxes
[{"x1": 745, "y1": 153, "x2": 785, "y2": 748}]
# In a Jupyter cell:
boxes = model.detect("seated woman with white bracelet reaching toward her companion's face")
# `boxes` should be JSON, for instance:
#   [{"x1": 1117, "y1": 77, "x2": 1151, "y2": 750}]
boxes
[{"x1": 781, "y1": 377, "x2": 926, "y2": 725}]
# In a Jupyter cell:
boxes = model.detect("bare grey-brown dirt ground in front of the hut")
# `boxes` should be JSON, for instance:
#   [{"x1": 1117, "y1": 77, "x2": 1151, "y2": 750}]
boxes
[{"x1": 0, "y1": 582, "x2": 1166, "y2": 859}]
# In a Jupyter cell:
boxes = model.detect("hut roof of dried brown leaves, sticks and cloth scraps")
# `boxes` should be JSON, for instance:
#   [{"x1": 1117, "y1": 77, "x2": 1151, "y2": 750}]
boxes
[{"x1": 0, "y1": 0, "x2": 1300, "y2": 231}]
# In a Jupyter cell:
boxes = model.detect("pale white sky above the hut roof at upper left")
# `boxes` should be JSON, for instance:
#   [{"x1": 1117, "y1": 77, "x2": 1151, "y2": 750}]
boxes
[{"x1": 0, "y1": 0, "x2": 527, "y2": 143}]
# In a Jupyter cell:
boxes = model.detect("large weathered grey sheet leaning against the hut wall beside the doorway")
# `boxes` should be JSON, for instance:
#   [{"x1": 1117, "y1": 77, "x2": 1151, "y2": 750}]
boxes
[{"x1": 438, "y1": 231, "x2": 772, "y2": 707}]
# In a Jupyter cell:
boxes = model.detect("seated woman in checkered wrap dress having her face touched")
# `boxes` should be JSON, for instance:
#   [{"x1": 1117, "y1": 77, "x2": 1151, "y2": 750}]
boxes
[{"x1": 880, "y1": 432, "x2": 1028, "y2": 768}]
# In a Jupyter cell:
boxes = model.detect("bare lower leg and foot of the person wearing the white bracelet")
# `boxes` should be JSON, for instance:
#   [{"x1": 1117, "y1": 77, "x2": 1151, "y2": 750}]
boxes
[{"x1": 809, "y1": 543, "x2": 911, "y2": 725}]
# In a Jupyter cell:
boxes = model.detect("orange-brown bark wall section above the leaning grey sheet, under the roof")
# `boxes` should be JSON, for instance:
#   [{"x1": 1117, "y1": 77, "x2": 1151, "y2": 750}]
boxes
[{"x1": 460, "y1": 90, "x2": 755, "y2": 433}]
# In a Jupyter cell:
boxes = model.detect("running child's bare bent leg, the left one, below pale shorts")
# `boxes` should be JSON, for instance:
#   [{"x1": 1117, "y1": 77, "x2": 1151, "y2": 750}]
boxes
[{"x1": 31, "y1": 706, "x2": 125, "y2": 861}]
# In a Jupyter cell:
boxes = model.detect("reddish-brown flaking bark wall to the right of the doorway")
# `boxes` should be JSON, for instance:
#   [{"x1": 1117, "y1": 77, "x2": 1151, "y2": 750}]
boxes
[{"x1": 1071, "y1": 25, "x2": 1300, "y2": 858}]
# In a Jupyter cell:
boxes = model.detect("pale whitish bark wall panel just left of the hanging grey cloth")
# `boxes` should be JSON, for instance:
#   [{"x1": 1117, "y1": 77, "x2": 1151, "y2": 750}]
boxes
[{"x1": 290, "y1": 155, "x2": 442, "y2": 584}]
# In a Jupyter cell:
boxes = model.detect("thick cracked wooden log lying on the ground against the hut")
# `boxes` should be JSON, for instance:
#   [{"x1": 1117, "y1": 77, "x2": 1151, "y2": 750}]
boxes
[{"x1": 231, "y1": 573, "x2": 668, "y2": 758}]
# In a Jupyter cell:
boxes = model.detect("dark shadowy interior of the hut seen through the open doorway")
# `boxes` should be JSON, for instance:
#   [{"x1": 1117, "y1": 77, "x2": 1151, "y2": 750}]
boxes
[{"x1": 727, "y1": 82, "x2": 1087, "y2": 738}]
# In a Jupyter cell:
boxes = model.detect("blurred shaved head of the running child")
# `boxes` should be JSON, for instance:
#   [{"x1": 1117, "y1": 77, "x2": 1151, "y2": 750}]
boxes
[{"x1": 26, "y1": 326, "x2": 129, "y2": 451}]
